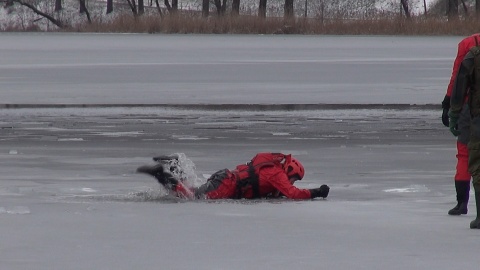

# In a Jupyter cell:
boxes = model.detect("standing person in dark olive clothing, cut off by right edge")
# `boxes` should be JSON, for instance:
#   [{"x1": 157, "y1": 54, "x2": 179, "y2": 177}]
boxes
[{"x1": 448, "y1": 43, "x2": 480, "y2": 229}]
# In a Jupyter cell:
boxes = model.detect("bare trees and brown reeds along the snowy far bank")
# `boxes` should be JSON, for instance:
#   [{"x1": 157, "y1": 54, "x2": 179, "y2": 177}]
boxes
[{"x1": 0, "y1": 0, "x2": 480, "y2": 34}]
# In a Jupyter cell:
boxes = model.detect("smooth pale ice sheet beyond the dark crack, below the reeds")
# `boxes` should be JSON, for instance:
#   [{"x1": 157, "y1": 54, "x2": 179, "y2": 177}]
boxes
[{"x1": 0, "y1": 33, "x2": 461, "y2": 104}]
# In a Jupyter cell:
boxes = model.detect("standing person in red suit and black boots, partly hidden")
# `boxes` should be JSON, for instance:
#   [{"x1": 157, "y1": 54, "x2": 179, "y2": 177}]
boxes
[{"x1": 442, "y1": 34, "x2": 480, "y2": 215}]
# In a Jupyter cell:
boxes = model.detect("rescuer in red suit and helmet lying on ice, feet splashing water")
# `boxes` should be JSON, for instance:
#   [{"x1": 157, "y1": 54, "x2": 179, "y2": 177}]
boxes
[{"x1": 137, "y1": 153, "x2": 330, "y2": 200}]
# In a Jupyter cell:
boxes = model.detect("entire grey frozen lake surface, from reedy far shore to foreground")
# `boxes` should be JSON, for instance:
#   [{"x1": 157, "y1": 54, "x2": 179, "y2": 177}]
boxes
[{"x1": 0, "y1": 33, "x2": 480, "y2": 270}]
